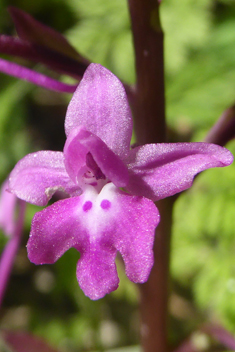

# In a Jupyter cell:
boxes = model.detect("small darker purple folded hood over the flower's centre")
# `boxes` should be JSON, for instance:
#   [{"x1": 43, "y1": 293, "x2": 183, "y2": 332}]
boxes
[{"x1": 64, "y1": 126, "x2": 129, "y2": 187}]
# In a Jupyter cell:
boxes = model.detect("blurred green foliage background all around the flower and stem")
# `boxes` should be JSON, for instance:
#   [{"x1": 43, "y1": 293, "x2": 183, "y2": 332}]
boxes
[{"x1": 0, "y1": 0, "x2": 235, "y2": 352}]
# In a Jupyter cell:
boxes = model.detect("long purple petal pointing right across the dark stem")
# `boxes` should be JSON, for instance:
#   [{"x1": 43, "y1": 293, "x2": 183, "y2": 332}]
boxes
[{"x1": 126, "y1": 143, "x2": 233, "y2": 201}]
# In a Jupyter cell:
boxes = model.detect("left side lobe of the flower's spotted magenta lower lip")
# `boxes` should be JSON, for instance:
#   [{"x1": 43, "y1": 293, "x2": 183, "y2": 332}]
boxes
[{"x1": 27, "y1": 197, "x2": 84, "y2": 264}]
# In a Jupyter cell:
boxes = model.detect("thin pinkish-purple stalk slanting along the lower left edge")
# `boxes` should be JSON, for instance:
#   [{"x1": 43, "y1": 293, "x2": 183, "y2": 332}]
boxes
[{"x1": 0, "y1": 200, "x2": 25, "y2": 307}]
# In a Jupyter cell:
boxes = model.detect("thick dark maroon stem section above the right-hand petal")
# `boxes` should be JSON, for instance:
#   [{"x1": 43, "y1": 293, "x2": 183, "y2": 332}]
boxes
[{"x1": 129, "y1": 0, "x2": 166, "y2": 144}]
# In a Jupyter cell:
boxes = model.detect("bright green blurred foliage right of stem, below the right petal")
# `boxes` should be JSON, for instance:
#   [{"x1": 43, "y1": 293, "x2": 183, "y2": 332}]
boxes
[{"x1": 171, "y1": 142, "x2": 235, "y2": 332}]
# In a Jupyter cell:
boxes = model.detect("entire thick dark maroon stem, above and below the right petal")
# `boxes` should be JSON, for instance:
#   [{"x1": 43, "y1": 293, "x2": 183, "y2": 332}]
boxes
[{"x1": 129, "y1": 0, "x2": 169, "y2": 352}]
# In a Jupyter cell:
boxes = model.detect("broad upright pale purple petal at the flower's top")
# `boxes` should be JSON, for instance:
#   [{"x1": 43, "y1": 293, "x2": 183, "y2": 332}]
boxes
[{"x1": 65, "y1": 64, "x2": 132, "y2": 158}]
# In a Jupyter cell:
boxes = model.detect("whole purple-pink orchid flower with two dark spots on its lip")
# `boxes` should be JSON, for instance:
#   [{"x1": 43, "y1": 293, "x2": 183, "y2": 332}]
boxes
[{"x1": 10, "y1": 64, "x2": 233, "y2": 299}]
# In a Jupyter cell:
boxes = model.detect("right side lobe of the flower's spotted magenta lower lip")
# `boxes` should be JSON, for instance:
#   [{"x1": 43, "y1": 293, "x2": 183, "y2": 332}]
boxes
[{"x1": 114, "y1": 190, "x2": 160, "y2": 283}]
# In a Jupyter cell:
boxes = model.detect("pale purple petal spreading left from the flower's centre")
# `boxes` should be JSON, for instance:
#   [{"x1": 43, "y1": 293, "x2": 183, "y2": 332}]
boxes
[{"x1": 9, "y1": 151, "x2": 80, "y2": 205}]
